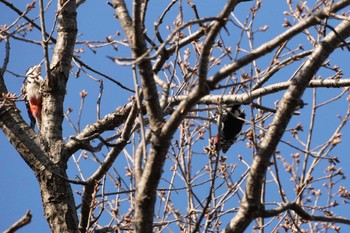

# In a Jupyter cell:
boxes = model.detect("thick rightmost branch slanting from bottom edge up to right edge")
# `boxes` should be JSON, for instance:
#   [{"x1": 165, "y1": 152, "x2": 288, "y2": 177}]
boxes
[{"x1": 224, "y1": 15, "x2": 350, "y2": 233}]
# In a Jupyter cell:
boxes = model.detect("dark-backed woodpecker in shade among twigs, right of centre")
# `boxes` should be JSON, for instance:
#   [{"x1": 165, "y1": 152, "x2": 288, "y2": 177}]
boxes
[{"x1": 214, "y1": 104, "x2": 245, "y2": 153}]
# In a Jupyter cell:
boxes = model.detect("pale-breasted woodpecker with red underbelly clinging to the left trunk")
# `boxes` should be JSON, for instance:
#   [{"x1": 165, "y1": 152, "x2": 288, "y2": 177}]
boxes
[{"x1": 22, "y1": 63, "x2": 44, "y2": 130}]
